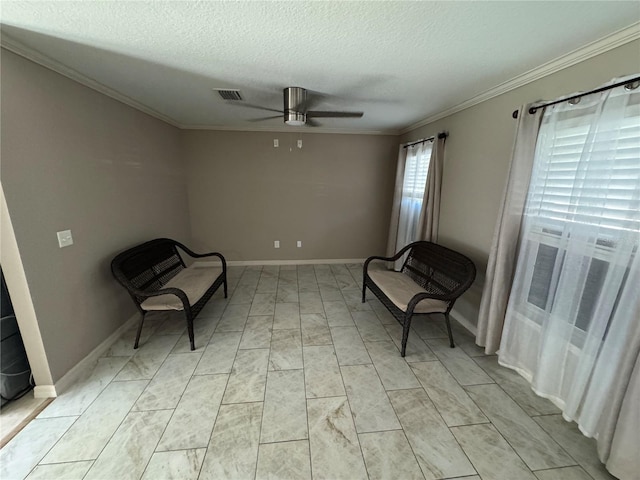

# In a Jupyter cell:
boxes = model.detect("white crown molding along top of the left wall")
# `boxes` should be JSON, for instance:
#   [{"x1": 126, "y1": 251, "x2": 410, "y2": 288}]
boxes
[{"x1": 0, "y1": 32, "x2": 180, "y2": 128}]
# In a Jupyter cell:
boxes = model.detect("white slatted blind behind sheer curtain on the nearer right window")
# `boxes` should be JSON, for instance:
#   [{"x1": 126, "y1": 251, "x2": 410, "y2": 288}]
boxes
[{"x1": 525, "y1": 109, "x2": 640, "y2": 238}]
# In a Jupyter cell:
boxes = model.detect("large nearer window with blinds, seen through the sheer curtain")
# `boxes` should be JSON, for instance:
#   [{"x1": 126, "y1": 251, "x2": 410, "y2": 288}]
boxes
[{"x1": 516, "y1": 86, "x2": 640, "y2": 346}]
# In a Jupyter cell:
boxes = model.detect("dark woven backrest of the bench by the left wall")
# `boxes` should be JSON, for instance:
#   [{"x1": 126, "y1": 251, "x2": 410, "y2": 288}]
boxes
[{"x1": 111, "y1": 238, "x2": 185, "y2": 292}]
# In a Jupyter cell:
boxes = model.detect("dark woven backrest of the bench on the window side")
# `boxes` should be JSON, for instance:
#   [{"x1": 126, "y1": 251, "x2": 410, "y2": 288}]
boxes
[{"x1": 402, "y1": 241, "x2": 476, "y2": 296}]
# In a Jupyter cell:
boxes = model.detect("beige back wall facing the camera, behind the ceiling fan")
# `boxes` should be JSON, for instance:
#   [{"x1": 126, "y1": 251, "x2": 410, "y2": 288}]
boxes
[{"x1": 183, "y1": 130, "x2": 398, "y2": 260}]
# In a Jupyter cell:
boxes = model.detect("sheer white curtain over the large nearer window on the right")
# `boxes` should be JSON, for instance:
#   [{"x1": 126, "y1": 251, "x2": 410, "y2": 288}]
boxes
[{"x1": 499, "y1": 76, "x2": 640, "y2": 471}]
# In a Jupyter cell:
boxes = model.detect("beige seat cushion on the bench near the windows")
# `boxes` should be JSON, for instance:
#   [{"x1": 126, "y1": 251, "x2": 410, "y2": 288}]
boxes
[{"x1": 368, "y1": 270, "x2": 449, "y2": 313}]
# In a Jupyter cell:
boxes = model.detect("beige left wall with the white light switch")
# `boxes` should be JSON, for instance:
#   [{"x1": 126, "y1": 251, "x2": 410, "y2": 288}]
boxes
[{"x1": 0, "y1": 49, "x2": 189, "y2": 382}]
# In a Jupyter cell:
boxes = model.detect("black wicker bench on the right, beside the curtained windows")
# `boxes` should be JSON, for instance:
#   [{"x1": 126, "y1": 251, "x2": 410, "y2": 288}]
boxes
[{"x1": 362, "y1": 241, "x2": 476, "y2": 357}]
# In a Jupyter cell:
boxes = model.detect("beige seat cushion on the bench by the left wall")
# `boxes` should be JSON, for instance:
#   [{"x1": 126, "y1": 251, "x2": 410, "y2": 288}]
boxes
[{"x1": 140, "y1": 266, "x2": 222, "y2": 311}]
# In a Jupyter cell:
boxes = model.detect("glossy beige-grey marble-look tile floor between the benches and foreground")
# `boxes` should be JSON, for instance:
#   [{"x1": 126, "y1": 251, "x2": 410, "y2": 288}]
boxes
[{"x1": 0, "y1": 264, "x2": 613, "y2": 480}]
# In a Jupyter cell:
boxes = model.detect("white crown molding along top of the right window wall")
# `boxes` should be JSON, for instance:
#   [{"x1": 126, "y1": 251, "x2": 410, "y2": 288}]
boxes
[{"x1": 399, "y1": 22, "x2": 640, "y2": 135}]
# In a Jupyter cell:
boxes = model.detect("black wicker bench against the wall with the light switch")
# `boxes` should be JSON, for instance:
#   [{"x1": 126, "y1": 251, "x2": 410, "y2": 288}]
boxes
[{"x1": 111, "y1": 238, "x2": 227, "y2": 350}]
